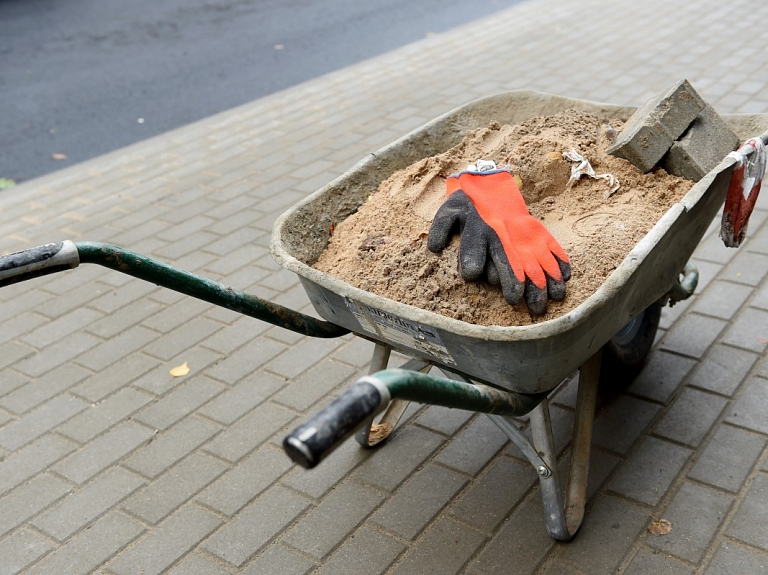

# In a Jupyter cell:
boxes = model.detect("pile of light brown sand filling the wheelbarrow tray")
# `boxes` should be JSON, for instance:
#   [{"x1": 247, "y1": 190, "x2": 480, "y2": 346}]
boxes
[{"x1": 314, "y1": 110, "x2": 693, "y2": 326}]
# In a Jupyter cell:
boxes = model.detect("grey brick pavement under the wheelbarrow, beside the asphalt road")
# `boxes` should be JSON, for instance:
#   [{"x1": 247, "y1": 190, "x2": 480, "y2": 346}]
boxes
[{"x1": 0, "y1": 0, "x2": 768, "y2": 575}]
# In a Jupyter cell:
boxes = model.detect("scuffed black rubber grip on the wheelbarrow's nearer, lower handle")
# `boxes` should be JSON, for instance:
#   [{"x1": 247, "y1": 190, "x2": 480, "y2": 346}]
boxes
[{"x1": 283, "y1": 381, "x2": 389, "y2": 469}]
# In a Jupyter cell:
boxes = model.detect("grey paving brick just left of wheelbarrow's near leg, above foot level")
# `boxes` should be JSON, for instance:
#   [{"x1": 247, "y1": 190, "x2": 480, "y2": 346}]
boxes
[{"x1": 450, "y1": 458, "x2": 537, "y2": 534}]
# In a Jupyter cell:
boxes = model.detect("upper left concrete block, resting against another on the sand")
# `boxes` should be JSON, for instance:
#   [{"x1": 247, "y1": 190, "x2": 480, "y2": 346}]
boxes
[{"x1": 606, "y1": 80, "x2": 706, "y2": 172}]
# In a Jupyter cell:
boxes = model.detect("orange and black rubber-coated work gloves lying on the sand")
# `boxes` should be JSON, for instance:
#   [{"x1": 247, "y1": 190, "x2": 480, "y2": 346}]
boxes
[{"x1": 427, "y1": 160, "x2": 571, "y2": 315}]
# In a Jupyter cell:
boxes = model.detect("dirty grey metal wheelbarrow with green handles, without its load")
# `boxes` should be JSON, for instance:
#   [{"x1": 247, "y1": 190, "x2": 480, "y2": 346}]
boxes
[{"x1": 0, "y1": 91, "x2": 768, "y2": 541}]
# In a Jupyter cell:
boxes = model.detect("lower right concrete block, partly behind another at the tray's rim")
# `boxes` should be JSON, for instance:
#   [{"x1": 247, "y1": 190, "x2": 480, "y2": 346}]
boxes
[{"x1": 664, "y1": 105, "x2": 739, "y2": 182}]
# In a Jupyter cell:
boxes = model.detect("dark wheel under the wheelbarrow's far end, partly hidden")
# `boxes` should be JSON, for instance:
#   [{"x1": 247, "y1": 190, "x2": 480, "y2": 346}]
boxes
[{"x1": 600, "y1": 299, "x2": 664, "y2": 392}]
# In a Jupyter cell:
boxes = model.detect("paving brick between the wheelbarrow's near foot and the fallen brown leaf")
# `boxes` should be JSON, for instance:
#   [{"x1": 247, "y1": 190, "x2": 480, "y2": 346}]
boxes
[{"x1": 557, "y1": 495, "x2": 648, "y2": 573}]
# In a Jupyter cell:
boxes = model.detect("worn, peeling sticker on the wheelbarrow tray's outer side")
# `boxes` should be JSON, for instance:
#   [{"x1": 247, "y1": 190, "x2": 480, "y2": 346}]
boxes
[{"x1": 344, "y1": 298, "x2": 456, "y2": 365}]
